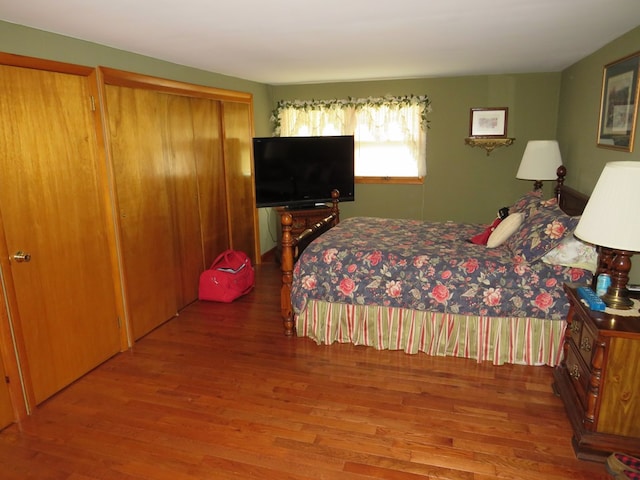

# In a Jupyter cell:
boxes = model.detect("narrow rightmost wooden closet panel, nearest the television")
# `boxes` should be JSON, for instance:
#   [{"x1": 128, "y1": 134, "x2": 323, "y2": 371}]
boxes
[{"x1": 222, "y1": 102, "x2": 260, "y2": 263}]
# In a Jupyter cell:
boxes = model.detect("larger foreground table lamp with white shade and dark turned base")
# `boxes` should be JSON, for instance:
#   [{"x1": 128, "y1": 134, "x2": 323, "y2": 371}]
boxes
[{"x1": 575, "y1": 161, "x2": 640, "y2": 309}]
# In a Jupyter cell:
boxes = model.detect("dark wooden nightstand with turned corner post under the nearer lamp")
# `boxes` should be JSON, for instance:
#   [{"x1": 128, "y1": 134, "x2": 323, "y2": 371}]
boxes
[{"x1": 554, "y1": 284, "x2": 640, "y2": 461}]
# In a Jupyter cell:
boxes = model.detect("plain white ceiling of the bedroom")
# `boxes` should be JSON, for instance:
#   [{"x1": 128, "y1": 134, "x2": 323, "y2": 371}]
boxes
[{"x1": 0, "y1": 0, "x2": 640, "y2": 84}]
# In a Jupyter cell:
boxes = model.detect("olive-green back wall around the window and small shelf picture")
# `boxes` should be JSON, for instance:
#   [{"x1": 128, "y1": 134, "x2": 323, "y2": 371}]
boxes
[{"x1": 272, "y1": 73, "x2": 561, "y2": 227}]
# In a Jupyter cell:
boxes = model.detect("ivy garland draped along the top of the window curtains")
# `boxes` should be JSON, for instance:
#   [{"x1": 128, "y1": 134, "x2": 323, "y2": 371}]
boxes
[{"x1": 271, "y1": 95, "x2": 431, "y2": 136}]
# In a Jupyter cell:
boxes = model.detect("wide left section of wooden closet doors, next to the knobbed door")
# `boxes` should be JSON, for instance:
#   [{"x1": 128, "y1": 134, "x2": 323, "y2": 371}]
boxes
[{"x1": 106, "y1": 85, "x2": 203, "y2": 339}]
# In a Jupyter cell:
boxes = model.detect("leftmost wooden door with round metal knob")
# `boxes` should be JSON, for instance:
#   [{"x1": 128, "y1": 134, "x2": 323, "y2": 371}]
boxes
[{"x1": 0, "y1": 65, "x2": 120, "y2": 406}]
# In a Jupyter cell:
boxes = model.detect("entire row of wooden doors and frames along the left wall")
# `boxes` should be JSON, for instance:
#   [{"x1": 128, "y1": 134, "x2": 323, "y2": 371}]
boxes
[{"x1": 0, "y1": 53, "x2": 260, "y2": 428}]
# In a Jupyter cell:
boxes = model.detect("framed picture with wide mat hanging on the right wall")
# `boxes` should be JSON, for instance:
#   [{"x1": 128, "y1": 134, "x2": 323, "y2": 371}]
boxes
[{"x1": 598, "y1": 52, "x2": 640, "y2": 152}]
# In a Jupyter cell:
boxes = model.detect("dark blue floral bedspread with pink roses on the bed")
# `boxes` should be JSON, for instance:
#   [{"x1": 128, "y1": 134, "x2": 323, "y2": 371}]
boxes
[{"x1": 292, "y1": 217, "x2": 591, "y2": 320}]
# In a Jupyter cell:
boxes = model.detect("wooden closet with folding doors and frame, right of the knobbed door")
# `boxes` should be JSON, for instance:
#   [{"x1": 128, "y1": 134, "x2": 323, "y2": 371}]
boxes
[{"x1": 100, "y1": 68, "x2": 258, "y2": 340}]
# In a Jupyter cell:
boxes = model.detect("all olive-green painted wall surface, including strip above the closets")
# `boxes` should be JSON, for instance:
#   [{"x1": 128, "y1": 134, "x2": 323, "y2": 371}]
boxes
[{"x1": 0, "y1": 21, "x2": 640, "y2": 282}]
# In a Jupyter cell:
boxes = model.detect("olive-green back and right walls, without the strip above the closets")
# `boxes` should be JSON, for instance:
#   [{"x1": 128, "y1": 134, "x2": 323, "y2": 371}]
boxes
[{"x1": 272, "y1": 27, "x2": 640, "y2": 283}]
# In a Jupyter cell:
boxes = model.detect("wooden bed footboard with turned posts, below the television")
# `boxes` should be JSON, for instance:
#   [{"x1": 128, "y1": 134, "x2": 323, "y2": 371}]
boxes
[{"x1": 280, "y1": 190, "x2": 340, "y2": 336}]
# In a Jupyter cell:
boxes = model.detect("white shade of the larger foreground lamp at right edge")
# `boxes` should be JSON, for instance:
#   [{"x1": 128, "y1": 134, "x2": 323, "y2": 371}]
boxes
[{"x1": 575, "y1": 161, "x2": 640, "y2": 252}]
